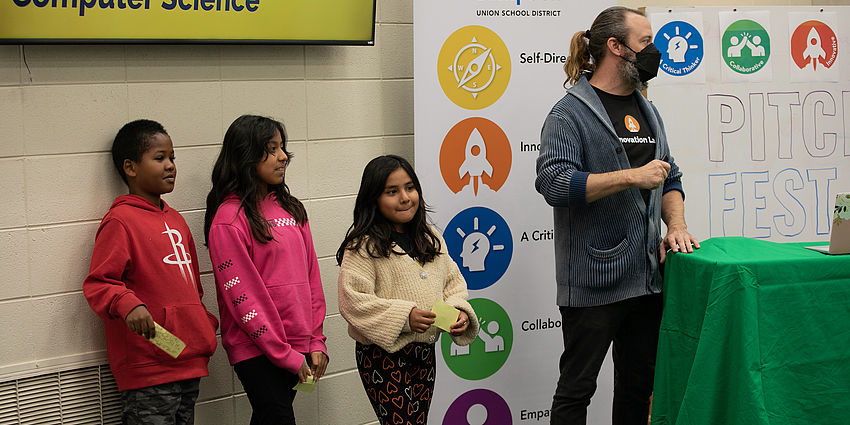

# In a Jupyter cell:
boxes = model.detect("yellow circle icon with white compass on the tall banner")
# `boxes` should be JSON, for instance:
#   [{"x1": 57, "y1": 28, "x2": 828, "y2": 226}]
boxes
[{"x1": 437, "y1": 25, "x2": 511, "y2": 109}]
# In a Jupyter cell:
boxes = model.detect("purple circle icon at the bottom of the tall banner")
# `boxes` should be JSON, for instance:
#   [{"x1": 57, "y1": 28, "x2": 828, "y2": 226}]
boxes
[{"x1": 443, "y1": 389, "x2": 513, "y2": 425}]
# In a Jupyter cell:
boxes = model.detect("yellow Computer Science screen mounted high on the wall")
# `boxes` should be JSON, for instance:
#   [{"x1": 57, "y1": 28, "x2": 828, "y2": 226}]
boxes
[{"x1": 0, "y1": 0, "x2": 375, "y2": 44}]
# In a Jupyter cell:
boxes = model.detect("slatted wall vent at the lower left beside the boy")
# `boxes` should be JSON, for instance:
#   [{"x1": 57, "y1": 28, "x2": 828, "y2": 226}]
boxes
[{"x1": 0, "y1": 365, "x2": 121, "y2": 425}]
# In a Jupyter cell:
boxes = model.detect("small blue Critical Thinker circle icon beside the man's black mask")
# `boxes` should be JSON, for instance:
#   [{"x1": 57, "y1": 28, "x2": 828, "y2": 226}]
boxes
[{"x1": 653, "y1": 21, "x2": 703, "y2": 77}]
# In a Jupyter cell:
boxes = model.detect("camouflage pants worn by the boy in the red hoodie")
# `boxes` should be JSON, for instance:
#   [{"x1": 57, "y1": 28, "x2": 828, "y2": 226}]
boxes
[{"x1": 121, "y1": 378, "x2": 201, "y2": 425}]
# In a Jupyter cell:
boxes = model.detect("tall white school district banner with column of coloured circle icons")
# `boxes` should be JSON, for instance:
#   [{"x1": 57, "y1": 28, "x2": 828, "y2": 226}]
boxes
[{"x1": 414, "y1": 0, "x2": 614, "y2": 425}]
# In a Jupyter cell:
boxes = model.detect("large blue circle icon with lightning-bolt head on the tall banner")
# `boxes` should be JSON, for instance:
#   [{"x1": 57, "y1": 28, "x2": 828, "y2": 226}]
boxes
[{"x1": 443, "y1": 207, "x2": 514, "y2": 289}]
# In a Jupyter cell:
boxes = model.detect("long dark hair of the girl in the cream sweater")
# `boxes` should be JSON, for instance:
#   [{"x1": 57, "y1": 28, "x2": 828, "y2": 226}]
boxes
[{"x1": 336, "y1": 155, "x2": 441, "y2": 264}]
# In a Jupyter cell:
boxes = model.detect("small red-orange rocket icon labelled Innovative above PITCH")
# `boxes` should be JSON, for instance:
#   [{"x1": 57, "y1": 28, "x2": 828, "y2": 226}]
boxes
[{"x1": 791, "y1": 21, "x2": 838, "y2": 72}]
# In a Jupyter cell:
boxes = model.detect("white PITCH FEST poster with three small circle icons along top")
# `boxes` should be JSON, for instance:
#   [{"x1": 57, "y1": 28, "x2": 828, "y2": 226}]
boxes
[{"x1": 647, "y1": 7, "x2": 850, "y2": 242}]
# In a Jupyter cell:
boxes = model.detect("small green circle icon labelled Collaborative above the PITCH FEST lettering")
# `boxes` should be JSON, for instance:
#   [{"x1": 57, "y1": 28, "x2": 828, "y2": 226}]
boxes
[{"x1": 721, "y1": 19, "x2": 770, "y2": 74}]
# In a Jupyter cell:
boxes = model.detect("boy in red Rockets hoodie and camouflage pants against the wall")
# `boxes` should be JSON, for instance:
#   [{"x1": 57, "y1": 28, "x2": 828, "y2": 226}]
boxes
[{"x1": 83, "y1": 120, "x2": 218, "y2": 425}]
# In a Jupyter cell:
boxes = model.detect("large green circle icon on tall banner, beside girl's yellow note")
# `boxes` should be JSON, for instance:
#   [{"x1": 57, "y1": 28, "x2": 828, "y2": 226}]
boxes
[{"x1": 440, "y1": 298, "x2": 514, "y2": 381}]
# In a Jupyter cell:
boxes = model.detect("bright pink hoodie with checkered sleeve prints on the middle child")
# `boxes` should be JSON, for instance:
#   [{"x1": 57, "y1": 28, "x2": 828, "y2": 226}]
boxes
[{"x1": 209, "y1": 195, "x2": 327, "y2": 373}]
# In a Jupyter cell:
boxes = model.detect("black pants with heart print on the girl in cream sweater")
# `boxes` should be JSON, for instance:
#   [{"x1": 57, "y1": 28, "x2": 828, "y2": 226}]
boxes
[{"x1": 354, "y1": 342, "x2": 437, "y2": 425}]
